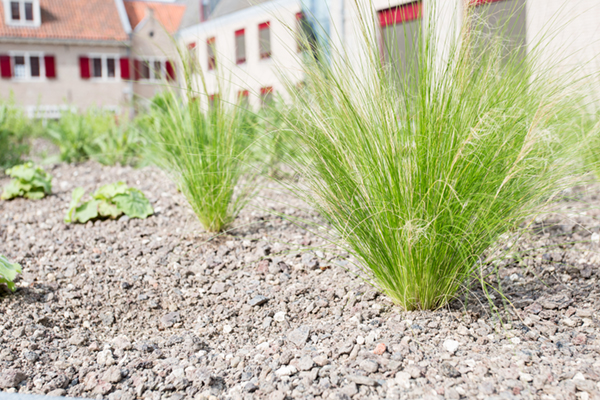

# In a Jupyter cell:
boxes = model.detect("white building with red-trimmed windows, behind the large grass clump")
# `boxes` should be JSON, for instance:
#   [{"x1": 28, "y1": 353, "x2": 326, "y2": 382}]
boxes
[{"x1": 179, "y1": 0, "x2": 600, "y2": 107}]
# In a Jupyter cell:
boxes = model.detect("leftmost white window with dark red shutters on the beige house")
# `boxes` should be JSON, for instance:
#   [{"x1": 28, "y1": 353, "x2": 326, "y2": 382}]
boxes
[{"x1": 0, "y1": 52, "x2": 56, "y2": 81}]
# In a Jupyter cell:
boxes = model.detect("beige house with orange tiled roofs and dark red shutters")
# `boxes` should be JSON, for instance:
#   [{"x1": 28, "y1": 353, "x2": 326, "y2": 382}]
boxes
[{"x1": 0, "y1": 0, "x2": 185, "y2": 118}]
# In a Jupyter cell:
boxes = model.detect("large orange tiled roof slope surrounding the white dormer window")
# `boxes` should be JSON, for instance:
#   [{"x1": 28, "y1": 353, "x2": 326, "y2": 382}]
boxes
[{"x1": 0, "y1": 0, "x2": 129, "y2": 42}]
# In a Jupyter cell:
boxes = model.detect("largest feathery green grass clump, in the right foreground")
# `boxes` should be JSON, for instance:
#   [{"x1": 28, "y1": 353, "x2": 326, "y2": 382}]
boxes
[{"x1": 289, "y1": 1, "x2": 592, "y2": 310}]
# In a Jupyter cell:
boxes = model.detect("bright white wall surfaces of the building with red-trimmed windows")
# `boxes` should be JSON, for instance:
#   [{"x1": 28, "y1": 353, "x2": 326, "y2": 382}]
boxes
[{"x1": 180, "y1": 0, "x2": 600, "y2": 106}]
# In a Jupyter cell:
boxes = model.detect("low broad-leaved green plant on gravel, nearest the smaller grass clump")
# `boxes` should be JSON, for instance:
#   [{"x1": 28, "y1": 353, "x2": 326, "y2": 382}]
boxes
[{"x1": 65, "y1": 182, "x2": 154, "y2": 223}]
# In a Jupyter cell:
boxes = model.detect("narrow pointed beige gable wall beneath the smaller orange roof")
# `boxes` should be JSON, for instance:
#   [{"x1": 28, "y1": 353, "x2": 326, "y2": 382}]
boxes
[{"x1": 131, "y1": 17, "x2": 179, "y2": 99}]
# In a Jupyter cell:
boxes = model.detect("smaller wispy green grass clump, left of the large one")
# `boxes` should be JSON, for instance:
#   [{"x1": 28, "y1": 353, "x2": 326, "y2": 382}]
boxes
[{"x1": 147, "y1": 52, "x2": 254, "y2": 232}]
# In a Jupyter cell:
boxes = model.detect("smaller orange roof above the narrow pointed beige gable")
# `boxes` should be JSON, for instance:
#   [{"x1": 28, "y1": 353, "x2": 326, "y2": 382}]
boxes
[{"x1": 125, "y1": 0, "x2": 186, "y2": 34}]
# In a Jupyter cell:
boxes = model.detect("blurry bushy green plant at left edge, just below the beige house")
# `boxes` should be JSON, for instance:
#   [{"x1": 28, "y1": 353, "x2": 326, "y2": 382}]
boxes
[{"x1": 0, "y1": 99, "x2": 32, "y2": 169}]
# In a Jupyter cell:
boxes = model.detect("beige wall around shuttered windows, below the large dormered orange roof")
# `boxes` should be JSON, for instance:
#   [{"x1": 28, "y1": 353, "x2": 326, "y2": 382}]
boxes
[{"x1": 0, "y1": 43, "x2": 128, "y2": 109}]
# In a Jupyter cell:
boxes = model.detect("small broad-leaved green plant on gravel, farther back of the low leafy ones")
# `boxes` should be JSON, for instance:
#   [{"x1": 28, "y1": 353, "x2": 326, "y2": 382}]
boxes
[{"x1": 1, "y1": 162, "x2": 52, "y2": 200}]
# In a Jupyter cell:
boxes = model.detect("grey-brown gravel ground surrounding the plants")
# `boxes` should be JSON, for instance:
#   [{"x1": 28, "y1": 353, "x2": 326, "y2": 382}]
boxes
[{"x1": 0, "y1": 163, "x2": 600, "y2": 400}]
